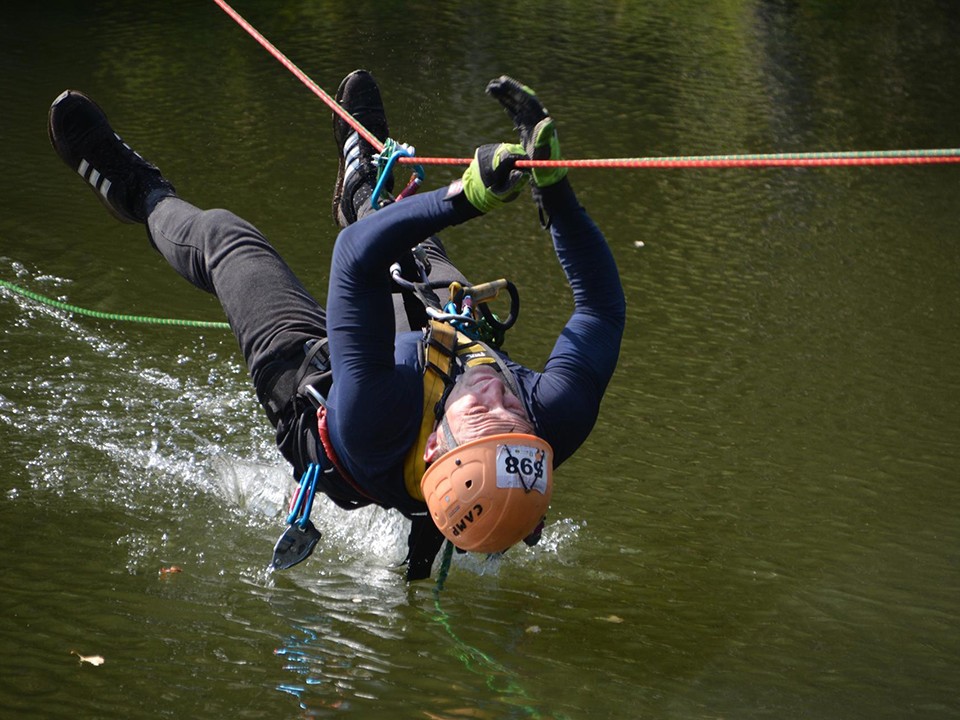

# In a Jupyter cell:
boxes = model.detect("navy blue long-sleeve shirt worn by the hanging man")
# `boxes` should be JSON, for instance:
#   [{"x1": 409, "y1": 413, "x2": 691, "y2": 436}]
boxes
[{"x1": 327, "y1": 181, "x2": 626, "y2": 514}]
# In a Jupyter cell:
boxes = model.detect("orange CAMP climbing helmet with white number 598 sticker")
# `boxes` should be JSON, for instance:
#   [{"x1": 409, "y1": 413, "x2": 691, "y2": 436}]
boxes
[{"x1": 420, "y1": 433, "x2": 553, "y2": 553}]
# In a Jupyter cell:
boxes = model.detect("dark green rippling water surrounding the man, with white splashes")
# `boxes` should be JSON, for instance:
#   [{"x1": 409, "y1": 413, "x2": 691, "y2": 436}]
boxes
[{"x1": 0, "y1": 0, "x2": 960, "y2": 719}]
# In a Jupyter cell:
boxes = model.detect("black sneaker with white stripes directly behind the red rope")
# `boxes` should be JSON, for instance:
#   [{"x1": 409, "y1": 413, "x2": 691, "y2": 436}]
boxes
[{"x1": 333, "y1": 70, "x2": 393, "y2": 227}]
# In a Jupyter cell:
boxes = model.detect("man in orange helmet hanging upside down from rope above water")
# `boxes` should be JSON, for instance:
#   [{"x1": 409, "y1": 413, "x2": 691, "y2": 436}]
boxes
[{"x1": 48, "y1": 70, "x2": 625, "y2": 580}]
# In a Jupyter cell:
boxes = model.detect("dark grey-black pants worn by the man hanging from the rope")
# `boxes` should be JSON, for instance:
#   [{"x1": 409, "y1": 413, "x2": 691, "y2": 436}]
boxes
[{"x1": 147, "y1": 197, "x2": 466, "y2": 475}]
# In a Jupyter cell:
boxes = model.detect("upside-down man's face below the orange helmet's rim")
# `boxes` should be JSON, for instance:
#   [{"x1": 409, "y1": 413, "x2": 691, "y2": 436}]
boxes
[{"x1": 445, "y1": 365, "x2": 534, "y2": 444}]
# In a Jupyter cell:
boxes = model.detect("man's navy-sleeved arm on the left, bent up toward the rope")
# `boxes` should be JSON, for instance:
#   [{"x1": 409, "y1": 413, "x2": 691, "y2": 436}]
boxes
[{"x1": 327, "y1": 188, "x2": 479, "y2": 480}]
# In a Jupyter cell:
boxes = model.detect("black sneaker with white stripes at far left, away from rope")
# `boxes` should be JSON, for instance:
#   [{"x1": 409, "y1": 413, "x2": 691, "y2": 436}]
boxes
[{"x1": 47, "y1": 90, "x2": 175, "y2": 223}]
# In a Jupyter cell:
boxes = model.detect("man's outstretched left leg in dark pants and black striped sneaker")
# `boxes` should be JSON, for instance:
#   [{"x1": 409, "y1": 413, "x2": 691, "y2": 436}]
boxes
[{"x1": 47, "y1": 90, "x2": 326, "y2": 442}]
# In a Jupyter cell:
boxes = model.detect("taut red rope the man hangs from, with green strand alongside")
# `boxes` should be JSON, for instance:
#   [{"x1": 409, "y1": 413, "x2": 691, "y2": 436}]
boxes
[{"x1": 213, "y1": 0, "x2": 960, "y2": 169}]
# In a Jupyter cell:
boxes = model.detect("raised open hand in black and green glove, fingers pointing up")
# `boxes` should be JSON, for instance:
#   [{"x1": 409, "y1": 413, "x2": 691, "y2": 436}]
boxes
[{"x1": 487, "y1": 75, "x2": 567, "y2": 187}]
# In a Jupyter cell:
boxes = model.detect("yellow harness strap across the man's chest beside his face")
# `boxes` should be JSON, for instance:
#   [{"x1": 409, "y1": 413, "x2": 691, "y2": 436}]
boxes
[{"x1": 403, "y1": 320, "x2": 497, "y2": 500}]
